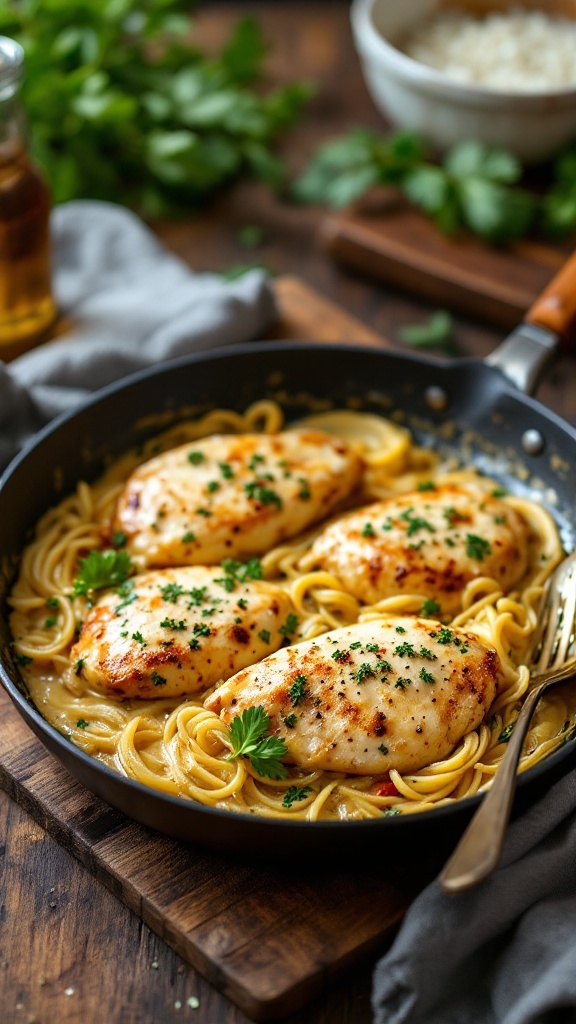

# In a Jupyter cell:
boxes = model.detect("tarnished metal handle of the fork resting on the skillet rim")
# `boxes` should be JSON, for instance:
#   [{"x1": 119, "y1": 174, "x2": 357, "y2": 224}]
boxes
[{"x1": 440, "y1": 664, "x2": 576, "y2": 893}]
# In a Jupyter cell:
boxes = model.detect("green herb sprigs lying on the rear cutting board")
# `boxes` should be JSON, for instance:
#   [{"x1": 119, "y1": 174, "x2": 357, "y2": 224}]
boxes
[{"x1": 293, "y1": 129, "x2": 576, "y2": 243}]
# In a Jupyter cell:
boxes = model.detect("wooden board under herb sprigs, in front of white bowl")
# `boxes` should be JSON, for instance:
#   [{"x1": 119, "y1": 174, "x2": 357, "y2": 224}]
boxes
[{"x1": 320, "y1": 196, "x2": 573, "y2": 330}]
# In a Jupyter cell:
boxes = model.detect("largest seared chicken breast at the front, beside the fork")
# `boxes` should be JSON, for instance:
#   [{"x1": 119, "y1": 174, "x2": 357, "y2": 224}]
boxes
[{"x1": 205, "y1": 617, "x2": 499, "y2": 775}]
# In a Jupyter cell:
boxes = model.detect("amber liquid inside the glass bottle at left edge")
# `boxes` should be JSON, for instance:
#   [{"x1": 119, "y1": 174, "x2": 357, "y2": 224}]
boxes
[{"x1": 0, "y1": 146, "x2": 55, "y2": 358}]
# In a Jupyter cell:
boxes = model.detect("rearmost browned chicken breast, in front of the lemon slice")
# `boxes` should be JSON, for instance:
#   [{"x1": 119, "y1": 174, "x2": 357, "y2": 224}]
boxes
[{"x1": 114, "y1": 430, "x2": 362, "y2": 566}]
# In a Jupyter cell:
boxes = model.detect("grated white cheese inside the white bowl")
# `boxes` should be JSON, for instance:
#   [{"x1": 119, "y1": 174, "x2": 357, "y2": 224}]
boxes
[{"x1": 402, "y1": 8, "x2": 576, "y2": 92}]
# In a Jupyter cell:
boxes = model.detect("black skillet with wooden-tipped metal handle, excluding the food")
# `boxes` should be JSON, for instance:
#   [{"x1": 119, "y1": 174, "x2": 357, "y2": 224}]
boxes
[{"x1": 0, "y1": 258, "x2": 576, "y2": 863}]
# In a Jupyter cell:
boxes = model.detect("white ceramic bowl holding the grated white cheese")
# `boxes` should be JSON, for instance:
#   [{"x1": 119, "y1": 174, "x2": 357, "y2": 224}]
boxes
[{"x1": 351, "y1": 0, "x2": 576, "y2": 163}]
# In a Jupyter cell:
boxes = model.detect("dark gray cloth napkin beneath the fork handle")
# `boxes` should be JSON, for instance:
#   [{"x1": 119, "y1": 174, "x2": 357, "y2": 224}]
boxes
[{"x1": 373, "y1": 771, "x2": 576, "y2": 1024}]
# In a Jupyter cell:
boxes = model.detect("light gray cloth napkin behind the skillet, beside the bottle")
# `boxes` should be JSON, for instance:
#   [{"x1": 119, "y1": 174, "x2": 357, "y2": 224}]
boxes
[{"x1": 0, "y1": 201, "x2": 277, "y2": 470}]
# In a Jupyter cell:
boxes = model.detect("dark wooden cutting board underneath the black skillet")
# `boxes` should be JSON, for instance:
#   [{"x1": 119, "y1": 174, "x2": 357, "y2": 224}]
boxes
[{"x1": 0, "y1": 278, "x2": 438, "y2": 1021}]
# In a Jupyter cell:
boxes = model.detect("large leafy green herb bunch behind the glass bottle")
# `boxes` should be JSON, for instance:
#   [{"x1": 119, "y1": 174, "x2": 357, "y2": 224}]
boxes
[{"x1": 0, "y1": 0, "x2": 311, "y2": 216}]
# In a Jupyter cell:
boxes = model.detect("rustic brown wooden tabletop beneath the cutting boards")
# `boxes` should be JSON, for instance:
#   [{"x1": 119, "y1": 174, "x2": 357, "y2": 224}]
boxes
[{"x1": 0, "y1": 0, "x2": 576, "y2": 1024}]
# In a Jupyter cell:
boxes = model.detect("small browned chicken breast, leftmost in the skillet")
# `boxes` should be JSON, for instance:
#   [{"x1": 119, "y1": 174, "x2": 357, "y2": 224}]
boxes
[{"x1": 71, "y1": 565, "x2": 292, "y2": 698}]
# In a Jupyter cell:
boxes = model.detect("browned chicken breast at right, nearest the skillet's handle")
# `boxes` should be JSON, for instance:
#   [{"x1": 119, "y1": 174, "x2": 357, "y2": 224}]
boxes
[{"x1": 310, "y1": 484, "x2": 529, "y2": 617}]
